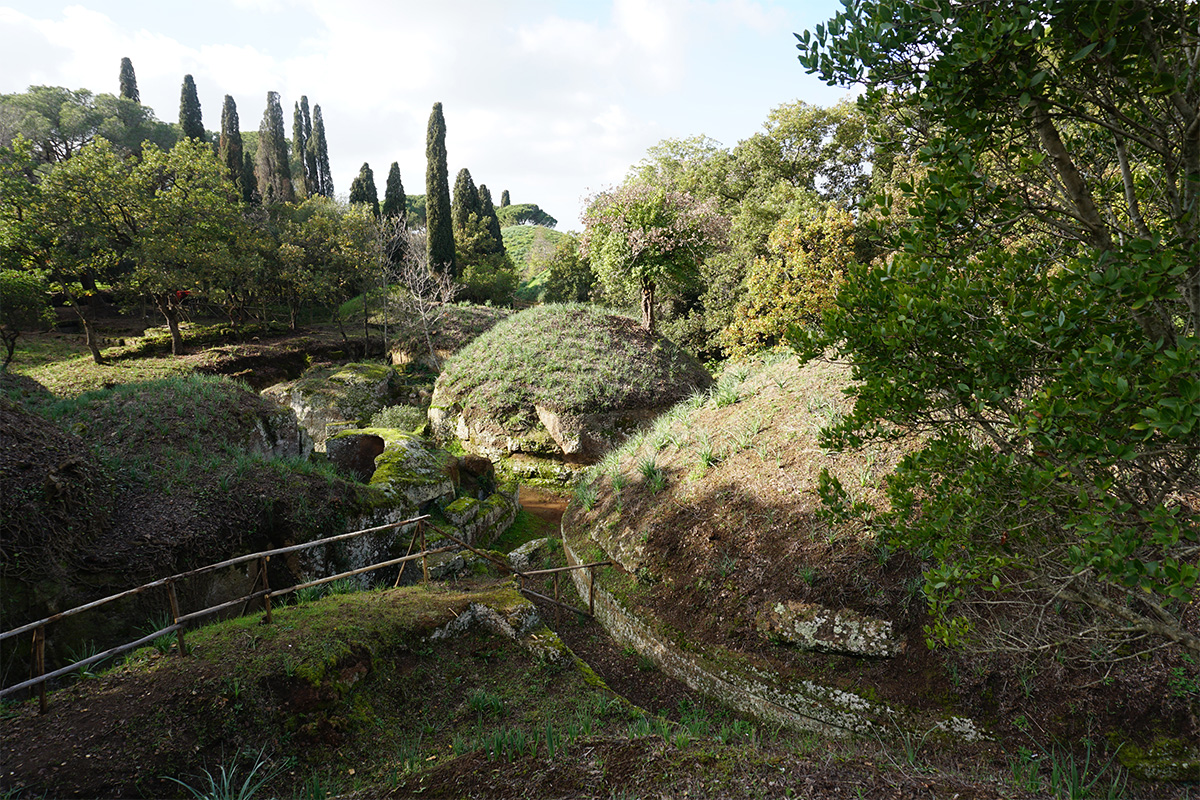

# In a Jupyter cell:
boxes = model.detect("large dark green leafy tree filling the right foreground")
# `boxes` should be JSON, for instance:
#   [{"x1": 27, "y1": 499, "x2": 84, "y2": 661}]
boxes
[{"x1": 798, "y1": 0, "x2": 1200, "y2": 662}]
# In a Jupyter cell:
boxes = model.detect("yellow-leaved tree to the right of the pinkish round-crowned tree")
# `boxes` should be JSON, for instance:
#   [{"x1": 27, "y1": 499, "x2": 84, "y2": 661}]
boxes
[{"x1": 721, "y1": 205, "x2": 857, "y2": 357}]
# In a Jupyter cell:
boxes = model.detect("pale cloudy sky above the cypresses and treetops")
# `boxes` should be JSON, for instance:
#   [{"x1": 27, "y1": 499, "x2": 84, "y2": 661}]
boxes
[{"x1": 0, "y1": 0, "x2": 847, "y2": 230}]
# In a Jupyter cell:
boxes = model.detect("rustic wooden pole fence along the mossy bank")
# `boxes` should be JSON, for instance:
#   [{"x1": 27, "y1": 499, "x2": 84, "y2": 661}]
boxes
[{"x1": 0, "y1": 516, "x2": 611, "y2": 714}]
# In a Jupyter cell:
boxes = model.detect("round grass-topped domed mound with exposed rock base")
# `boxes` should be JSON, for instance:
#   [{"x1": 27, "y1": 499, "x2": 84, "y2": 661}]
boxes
[{"x1": 432, "y1": 306, "x2": 712, "y2": 455}]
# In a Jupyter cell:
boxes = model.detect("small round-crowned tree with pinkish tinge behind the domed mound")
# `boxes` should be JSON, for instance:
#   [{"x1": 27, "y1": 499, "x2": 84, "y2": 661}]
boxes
[{"x1": 583, "y1": 184, "x2": 727, "y2": 332}]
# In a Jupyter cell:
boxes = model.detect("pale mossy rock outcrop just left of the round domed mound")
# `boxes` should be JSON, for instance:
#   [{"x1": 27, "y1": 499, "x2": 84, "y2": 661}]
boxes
[{"x1": 262, "y1": 363, "x2": 403, "y2": 451}]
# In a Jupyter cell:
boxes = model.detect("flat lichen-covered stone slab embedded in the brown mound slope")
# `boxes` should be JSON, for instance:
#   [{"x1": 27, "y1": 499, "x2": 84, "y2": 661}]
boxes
[{"x1": 756, "y1": 601, "x2": 905, "y2": 657}]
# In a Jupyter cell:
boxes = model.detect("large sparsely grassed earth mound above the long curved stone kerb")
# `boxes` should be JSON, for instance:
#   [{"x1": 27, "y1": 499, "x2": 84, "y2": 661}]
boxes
[{"x1": 563, "y1": 359, "x2": 1200, "y2": 796}]
